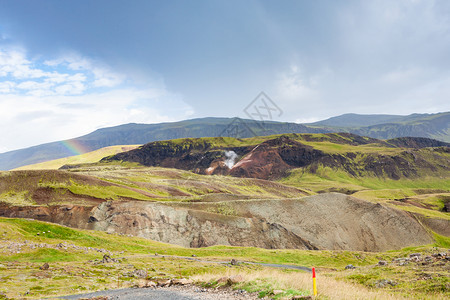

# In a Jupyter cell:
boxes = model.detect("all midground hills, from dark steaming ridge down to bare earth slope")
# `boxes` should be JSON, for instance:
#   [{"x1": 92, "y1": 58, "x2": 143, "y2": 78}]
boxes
[{"x1": 0, "y1": 134, "x2": 450, "y2": 251}]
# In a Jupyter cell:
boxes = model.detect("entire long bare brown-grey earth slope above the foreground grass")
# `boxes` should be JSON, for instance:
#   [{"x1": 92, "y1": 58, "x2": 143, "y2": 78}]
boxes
[{"x1": 0, "y1": 193, "x2": 433, "y2": 251}]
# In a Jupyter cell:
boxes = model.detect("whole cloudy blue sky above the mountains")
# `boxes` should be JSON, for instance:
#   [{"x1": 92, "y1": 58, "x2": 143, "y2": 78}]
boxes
[{"x1": 0, "y1": 0, "x2": 450, "y2": 152}]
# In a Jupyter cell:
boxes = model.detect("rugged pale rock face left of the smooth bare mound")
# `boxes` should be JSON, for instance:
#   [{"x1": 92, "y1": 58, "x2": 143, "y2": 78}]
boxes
[{"x1": 91, "y1": 202, "x2": 315, "y2": 249}]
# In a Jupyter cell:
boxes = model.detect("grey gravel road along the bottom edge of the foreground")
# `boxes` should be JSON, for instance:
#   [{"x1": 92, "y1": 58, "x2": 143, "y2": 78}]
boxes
[{"x1": 61, "y1": 286, "x2": 259, "y2": 300}]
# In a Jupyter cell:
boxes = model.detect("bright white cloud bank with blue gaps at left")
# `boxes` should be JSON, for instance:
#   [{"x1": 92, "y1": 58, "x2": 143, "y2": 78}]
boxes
[{"x1": 0, "y1": 47, "x2": 193, "y2": 152}]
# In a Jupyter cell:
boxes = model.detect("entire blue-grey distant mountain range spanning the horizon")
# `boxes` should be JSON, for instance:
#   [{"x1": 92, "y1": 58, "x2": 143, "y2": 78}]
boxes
[{"x1": 0, "y1": 112, "x2": 450, "y2": 170}]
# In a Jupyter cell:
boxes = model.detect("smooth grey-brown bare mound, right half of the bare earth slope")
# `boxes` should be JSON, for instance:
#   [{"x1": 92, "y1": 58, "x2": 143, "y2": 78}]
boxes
[{"x1": 221, "y1": 193, "x2": 432, "y2": 251}]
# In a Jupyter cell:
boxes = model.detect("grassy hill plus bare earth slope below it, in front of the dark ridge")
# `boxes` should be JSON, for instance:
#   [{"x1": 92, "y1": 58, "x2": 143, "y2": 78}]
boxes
[{"x1": 0, "y1": 165, "x2": 450, "y2": 251}]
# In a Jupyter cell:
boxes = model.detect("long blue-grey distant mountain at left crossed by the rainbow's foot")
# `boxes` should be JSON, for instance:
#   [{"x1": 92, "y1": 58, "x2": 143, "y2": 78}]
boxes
[{"x1": 0, "y1": 118, "x2": 327, "y2": 170}]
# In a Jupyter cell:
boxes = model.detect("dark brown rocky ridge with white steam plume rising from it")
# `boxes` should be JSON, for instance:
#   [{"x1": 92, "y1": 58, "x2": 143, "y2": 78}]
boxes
[{"x1": 102, "y1": 133, "x2": 450, "y2": 179}]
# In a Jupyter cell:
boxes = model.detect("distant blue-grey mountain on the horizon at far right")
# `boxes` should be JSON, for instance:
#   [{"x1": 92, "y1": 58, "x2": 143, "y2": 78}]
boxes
[{"x1": 305, "y1": 112, "x2": 450, "y2": 142}]
